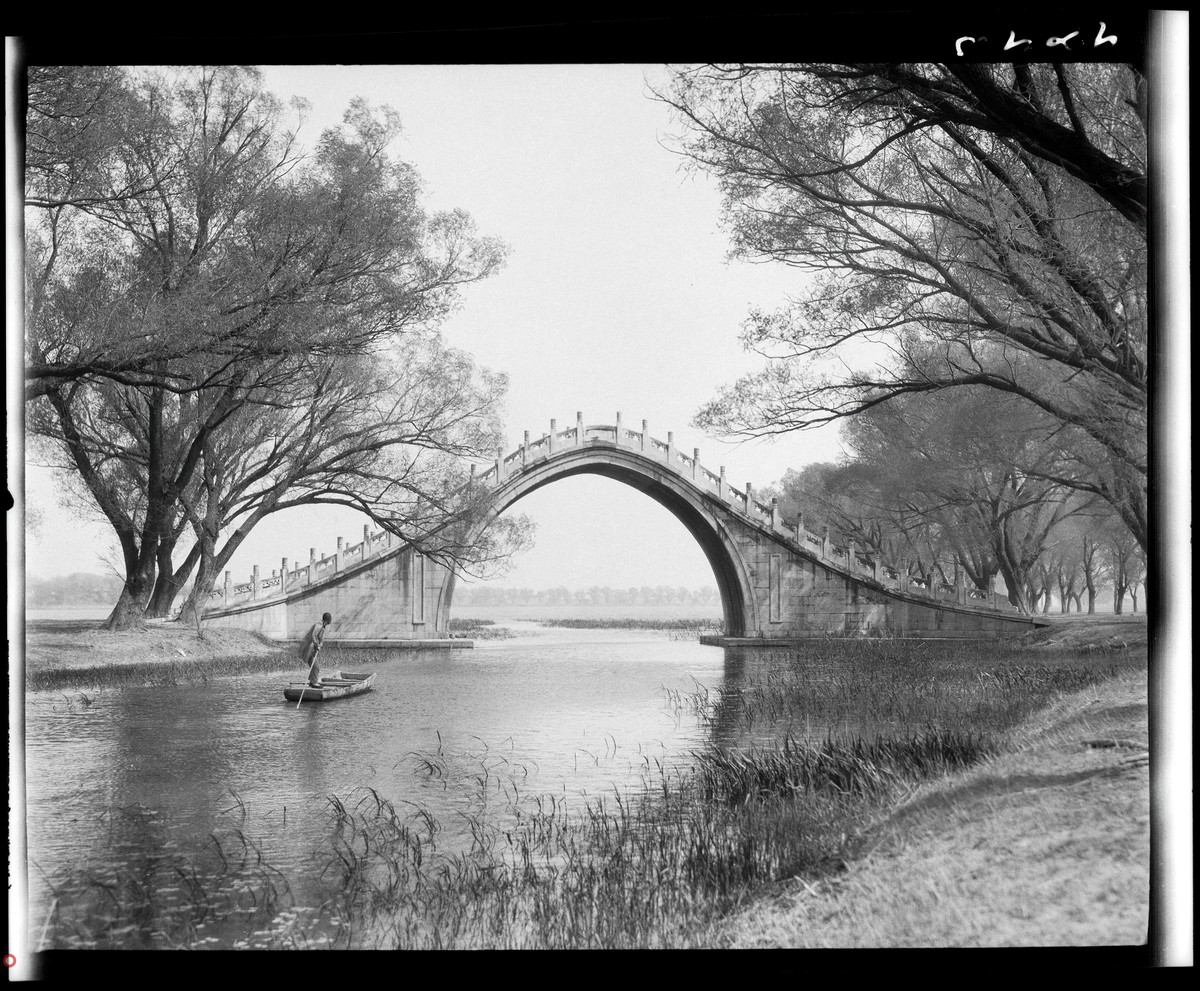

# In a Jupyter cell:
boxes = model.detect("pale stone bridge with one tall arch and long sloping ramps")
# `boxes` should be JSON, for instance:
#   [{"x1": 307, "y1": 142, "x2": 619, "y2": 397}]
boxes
[{"x1": 204, "y1": 413, "x2": 1045, "y2": 645}]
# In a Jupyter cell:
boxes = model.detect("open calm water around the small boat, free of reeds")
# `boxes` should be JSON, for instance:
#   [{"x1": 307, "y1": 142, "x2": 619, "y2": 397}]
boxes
[{"x1": 26, "y1": 624, "x2": 732, "y2": 931}]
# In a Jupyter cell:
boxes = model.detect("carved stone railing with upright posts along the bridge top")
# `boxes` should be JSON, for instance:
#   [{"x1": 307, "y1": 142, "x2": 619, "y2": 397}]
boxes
[{"x1": 209, "y1": 413, "x2": 1016, "y2": 612}]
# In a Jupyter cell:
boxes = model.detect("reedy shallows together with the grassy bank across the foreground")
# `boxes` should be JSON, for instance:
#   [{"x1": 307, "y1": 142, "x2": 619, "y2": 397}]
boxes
[{"x1": 28, "y1": 619, "x2": 1148, "y2": 948}]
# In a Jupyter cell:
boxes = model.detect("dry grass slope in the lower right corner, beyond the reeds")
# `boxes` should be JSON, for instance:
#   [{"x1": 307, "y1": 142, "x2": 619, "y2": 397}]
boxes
[{"x1": 706, "y1": 673, "x2": 1150, "y2": 948}]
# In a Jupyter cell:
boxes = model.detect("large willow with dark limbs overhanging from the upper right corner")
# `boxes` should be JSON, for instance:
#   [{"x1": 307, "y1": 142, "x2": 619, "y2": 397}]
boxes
[{"x1": 660, "y1": 64, "x2": 1147, "y2": 547}]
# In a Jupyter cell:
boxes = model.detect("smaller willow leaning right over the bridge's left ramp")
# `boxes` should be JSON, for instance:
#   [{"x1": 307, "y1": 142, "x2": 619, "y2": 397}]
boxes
[{"x1": 175, "y1": 334, "x2": 529, "y2": 623}]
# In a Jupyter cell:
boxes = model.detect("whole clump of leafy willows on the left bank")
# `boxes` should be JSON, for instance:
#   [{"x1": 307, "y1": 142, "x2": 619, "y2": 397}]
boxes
[{"x1": 25, "y1": 66, "x2": 518, "y2": 625}]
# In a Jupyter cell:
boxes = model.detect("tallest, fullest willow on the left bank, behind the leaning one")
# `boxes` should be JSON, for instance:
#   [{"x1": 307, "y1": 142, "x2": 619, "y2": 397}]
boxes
[{"x1": 25, "y1": 67, "x2": 503, "y2": 626}]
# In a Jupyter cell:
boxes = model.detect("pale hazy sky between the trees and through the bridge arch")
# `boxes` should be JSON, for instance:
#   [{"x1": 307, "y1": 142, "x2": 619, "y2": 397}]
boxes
[{"x1": 18, "y1": 65, "x2": 838, "y2": 588}]
